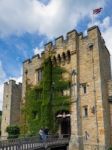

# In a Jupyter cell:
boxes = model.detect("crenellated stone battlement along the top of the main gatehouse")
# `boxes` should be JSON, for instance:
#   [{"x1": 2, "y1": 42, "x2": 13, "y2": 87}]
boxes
[{"x1": 23, "y1": 26, "x2": 102, "y2": 64}]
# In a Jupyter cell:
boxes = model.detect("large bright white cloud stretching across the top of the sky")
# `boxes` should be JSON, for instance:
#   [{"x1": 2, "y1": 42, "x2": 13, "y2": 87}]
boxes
[{"x1": 0, "y1": 0, "x2": 106, "y2": 37}]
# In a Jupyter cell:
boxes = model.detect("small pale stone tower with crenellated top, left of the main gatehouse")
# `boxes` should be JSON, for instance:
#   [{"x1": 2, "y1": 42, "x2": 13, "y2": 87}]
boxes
[{"x1": 1, "y1": 80, "x2": 22, "y2": 139}]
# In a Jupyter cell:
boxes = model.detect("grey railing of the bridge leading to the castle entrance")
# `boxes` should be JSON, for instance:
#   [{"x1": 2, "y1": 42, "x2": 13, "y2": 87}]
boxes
[{"x1": 0, "y1": 135, "x2": 69, "y2": 150}]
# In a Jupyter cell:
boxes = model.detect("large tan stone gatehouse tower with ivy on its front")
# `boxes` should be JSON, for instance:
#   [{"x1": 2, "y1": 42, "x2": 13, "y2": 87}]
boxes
[{"x1": 21, "y1": 26, "x2": 111, "y2": 150}]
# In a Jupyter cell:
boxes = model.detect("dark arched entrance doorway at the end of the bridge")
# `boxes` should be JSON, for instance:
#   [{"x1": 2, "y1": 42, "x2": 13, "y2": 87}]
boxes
[{"x1": 56, "y1": 111, "x2": 71, "y2": 137}]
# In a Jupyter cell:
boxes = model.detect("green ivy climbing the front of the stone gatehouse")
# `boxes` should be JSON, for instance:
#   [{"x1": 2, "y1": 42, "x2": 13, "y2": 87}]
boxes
[{"x1": 24, "y1": 58, "x2": 69, "y2": 134}]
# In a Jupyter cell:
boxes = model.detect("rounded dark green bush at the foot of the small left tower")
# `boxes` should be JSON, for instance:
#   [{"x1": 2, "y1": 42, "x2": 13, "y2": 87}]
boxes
[{"x1": 6, "y1": 125, "x2": 20, "y2": 139}]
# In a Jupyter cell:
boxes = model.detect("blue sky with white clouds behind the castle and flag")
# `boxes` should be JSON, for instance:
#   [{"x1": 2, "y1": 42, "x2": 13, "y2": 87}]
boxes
[{"x1": 0, "y1": 0, "x2": 112, "y2": 110}]
